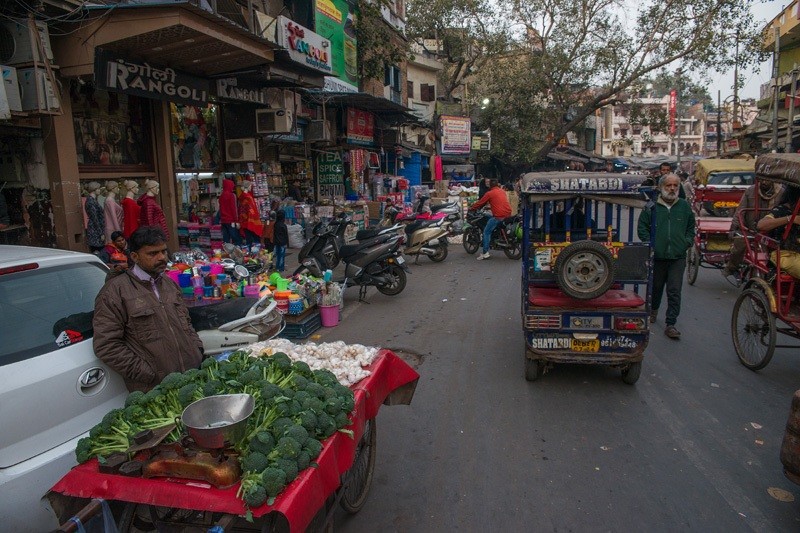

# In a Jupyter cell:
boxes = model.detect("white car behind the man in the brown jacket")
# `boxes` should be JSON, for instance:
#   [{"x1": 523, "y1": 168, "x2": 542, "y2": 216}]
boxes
[{"x1": 0, "y1": 246, "x2": 127, "y2": 531}]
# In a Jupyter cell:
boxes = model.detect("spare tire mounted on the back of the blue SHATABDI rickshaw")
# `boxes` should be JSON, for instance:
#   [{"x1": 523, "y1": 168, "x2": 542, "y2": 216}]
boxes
[{"x1": 555, "y1": 241, "x2": 614, "y2": 300}]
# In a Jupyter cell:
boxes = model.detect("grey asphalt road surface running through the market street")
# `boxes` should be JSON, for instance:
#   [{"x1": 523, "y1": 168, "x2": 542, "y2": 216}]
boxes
[{"x1": 310, "y1": 246, "x2": 800, "y2": 532}]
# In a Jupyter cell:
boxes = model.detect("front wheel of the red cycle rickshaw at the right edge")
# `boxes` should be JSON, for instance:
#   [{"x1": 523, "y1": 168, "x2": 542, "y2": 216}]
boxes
[{"x1": 731, "y1": 288, "x2": 776, "y2": 370}]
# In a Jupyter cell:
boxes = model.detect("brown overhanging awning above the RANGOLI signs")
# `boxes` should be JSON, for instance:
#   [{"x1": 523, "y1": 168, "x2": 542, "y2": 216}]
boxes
[{"x1": 53, "y1": 1, "x2": 278, "y2": 78}]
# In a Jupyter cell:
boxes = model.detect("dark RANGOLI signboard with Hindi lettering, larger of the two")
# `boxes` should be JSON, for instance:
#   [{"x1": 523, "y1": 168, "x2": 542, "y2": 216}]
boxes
[{"x1": 94, "y1": 49, "x2": 211, "y2": 105}]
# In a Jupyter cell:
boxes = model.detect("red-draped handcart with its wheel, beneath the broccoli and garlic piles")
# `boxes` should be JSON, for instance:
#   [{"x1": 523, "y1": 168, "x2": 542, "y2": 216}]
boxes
[{"x1": 48, "y1": 350, "x2": 419, "y2": 532}]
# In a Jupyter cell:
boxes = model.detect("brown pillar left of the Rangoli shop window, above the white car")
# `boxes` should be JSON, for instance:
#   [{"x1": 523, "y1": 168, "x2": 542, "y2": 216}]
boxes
[{"x1": 42, "y1": 82, "x2": 88, "y2": 251}]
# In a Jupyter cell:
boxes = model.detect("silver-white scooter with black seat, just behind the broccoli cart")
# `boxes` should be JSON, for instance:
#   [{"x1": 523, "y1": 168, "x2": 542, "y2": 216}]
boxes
[{"x1": 189, "y1": 296, "x2": 286, "y2": 355}]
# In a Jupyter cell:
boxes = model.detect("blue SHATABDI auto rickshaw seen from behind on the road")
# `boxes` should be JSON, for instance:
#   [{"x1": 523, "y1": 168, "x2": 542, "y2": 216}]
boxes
[{"x1": 521, "y1": 172, "x2": 655, "y2": 384}]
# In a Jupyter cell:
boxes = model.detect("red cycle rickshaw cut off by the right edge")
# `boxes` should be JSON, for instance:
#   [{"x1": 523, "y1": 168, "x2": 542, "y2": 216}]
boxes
[{"x1": 731, "y1": 154, "x2": 800, "y2": 370}]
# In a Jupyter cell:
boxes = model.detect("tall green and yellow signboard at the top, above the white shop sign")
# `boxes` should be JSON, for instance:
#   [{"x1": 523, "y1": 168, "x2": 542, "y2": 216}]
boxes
[{"x1": 314, "y1": 0, "x2": 358, "y2": 86}]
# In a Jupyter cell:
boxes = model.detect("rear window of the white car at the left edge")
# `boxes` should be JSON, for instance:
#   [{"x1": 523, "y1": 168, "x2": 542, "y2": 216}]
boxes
[{"x1": 0, "y1": 263, "x2": 106, "y2": 366}]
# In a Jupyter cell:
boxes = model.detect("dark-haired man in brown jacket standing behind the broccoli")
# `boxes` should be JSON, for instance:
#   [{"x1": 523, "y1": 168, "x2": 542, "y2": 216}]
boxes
[{"x1": 93, "y1": 226, "x2": 203, "y2": 391}]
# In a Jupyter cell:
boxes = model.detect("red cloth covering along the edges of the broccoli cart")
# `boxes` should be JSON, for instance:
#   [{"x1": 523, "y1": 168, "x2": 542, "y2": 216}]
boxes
[{"x1": 51, "y1": 350, "x2": 419, "y2": 531}]
